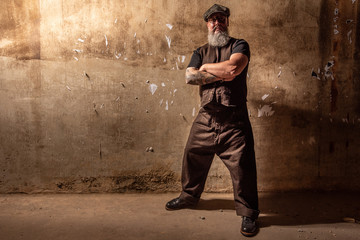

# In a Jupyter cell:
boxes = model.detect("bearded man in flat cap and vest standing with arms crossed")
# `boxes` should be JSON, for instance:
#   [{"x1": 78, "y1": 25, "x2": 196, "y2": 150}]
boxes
[{"x1": 165, "y1": 4, "x2": 259, "y2": 237}]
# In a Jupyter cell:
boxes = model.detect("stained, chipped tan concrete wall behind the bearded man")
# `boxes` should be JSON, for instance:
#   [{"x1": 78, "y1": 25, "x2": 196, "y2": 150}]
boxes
[{"x1": 0, "y1": 0, "x2": 360, "y2": 193}]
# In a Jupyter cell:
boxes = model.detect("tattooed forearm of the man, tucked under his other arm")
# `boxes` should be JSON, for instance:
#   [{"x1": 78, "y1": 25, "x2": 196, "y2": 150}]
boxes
[{"x1": 185, "y1": 67, "x2": 222, "y2": 85}]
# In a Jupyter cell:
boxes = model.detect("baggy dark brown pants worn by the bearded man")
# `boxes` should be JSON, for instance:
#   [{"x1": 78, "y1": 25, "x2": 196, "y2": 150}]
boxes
[{"x1": 180, "y1": 106, "x2": 259, "y2": 218}]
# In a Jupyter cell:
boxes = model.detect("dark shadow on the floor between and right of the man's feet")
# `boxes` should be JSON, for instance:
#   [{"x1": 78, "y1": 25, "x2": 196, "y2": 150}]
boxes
[{"x1": 196, "y1": 193, "x2": 360, "y2": 227}]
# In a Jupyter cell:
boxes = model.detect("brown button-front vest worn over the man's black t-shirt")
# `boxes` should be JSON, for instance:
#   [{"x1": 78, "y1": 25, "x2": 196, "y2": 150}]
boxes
[{"x1": 199, "y1": 38, "x2": 248, "y2": 108}]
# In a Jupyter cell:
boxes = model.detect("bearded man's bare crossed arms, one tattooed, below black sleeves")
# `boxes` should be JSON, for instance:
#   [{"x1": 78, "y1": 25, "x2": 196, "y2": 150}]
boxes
[{"x1": 185, "y1": 53, "x2": 249, "y2": 85}]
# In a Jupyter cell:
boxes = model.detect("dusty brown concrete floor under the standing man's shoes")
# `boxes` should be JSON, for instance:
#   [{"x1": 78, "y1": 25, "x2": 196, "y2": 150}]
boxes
[{"x1": 0, "y1": 193, "x2": 360, "y2": 240}]
